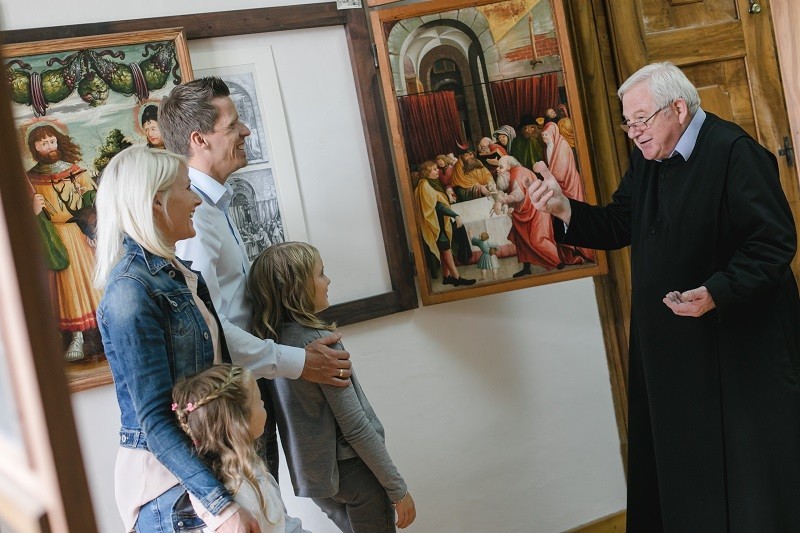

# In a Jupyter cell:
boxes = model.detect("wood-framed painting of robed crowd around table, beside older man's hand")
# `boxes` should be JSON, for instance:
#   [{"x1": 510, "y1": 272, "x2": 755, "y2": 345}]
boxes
[{"x1": 370, "y1": 0, "x2": 606, "y2": 304}]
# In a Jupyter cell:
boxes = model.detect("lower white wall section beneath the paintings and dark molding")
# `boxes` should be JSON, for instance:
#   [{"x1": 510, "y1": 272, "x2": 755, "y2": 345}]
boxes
[{"x1": 74, "y1": 280, "x2": 625, "y2": 533}]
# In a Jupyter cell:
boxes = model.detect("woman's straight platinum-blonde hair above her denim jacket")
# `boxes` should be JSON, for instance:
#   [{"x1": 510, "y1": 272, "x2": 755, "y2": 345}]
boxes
[{"x1": 94, "y1": 145, "x2": 186, "y2": 289}]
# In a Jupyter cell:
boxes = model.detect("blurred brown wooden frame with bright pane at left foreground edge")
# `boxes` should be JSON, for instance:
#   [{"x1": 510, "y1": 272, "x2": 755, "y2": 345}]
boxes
[{"x1": 0, "y1": 44, "x2": 97, "y2": 533}]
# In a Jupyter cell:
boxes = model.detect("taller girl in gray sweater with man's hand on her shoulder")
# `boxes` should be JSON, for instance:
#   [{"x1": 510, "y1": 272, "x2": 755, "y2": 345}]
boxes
[{"x1": 248, "y1": 242, "x2": 416, "y2": 533}]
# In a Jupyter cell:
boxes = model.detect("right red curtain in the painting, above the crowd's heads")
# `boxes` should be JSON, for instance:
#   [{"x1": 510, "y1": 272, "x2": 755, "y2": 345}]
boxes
[{"x1": 491, "y1": 74, "x2": 559, "y2": 129}]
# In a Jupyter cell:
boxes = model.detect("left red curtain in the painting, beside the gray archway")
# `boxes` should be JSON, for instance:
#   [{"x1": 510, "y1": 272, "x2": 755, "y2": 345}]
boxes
[{"x1": 397, "y1": 91, "x2": 466, "y2": 166}]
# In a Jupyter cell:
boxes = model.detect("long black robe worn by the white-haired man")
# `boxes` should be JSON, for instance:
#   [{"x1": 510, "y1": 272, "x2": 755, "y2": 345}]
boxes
[{"x1": 564, "y1": 113, "x2": 800, "y2": 533}]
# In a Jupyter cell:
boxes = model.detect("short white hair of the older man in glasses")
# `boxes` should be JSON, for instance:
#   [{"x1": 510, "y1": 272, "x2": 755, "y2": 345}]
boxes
[{"x1": 617, "y1": 61, "x2": 700, "y2": 116}]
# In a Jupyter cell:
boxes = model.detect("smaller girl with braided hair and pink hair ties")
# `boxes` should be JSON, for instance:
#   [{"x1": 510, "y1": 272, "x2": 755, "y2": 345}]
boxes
[{"x1": 172, "y1": 364, "x2": 308, "y2": 533}]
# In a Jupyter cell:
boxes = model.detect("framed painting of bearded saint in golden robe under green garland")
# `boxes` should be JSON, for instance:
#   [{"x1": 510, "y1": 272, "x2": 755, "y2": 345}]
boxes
[{"x1": 2, "y1": 28, "x2": 192, "y2": 390}]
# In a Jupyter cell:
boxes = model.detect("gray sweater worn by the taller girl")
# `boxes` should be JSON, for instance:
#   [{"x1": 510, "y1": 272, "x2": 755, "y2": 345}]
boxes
[{"x1": 271, "y1": 323, "x2": 407, "y2": 502}]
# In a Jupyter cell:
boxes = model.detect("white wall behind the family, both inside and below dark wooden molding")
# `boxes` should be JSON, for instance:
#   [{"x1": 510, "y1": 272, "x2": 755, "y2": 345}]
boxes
[{"x1": 0, "y1": 0, "x2": 625, "y2": 533}]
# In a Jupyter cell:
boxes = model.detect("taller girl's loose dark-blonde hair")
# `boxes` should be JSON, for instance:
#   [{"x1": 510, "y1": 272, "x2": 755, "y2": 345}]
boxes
[{"x1": 252, "y1": 242, "x2": 336, "y2": 340}]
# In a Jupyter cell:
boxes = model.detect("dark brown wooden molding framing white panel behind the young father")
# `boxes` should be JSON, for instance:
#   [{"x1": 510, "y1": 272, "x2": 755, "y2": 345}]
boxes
[{"x1": 0, "y1": 2, "x2": 419, "y2": 392}]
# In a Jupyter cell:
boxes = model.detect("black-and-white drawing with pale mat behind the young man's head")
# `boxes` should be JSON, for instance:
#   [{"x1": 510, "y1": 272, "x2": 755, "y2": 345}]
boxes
[{"x1": 192, "y1": 45, "x2": 308, "y2": 259}]
